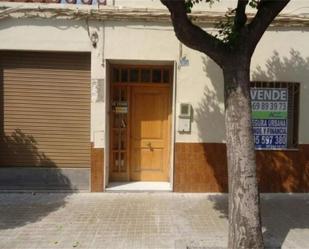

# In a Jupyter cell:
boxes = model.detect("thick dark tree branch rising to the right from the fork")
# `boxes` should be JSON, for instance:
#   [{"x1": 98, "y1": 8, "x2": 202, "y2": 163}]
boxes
[{"x1": 248, "y1": 0, "x2": 290, "y2": 55}]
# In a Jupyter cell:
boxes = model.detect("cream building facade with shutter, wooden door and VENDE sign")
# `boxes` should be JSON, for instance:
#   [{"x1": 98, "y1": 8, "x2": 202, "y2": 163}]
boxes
[{"x1": 0, "y1": 0, "x2": 309, "y2": 192}]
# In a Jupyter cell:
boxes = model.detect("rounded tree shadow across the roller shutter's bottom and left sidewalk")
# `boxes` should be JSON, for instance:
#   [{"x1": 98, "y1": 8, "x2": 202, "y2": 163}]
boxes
[{"x1": 0, "y1": 129, "x2": 74, "y2": 230}]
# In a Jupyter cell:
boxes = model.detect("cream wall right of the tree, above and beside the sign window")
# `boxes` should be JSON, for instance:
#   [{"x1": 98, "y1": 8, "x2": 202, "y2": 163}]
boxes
[{"x1": 251, "y1": 28, "x2": 309, "y2": 144}]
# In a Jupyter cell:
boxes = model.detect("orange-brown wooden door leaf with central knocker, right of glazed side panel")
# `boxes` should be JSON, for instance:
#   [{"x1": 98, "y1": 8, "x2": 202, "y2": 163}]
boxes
[{"x1": 130, "y1": 86, "x2": 170, "y2": 181}]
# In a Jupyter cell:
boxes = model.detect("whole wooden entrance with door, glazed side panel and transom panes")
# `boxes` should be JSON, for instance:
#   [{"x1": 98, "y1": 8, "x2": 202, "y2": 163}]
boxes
[{"x1": 109, "y1": 65, "x2": 173, "y2": 182}]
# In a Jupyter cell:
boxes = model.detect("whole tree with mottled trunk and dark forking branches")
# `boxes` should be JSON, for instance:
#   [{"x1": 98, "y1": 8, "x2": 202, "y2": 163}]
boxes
[{"x1": 161, "y1": 0, "x2": 290, "y2": 249}]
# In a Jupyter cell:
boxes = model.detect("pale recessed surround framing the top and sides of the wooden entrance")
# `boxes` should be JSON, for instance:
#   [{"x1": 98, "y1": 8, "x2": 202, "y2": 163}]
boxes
[{"x1": 104, "y1": 60, "x2": 177, "y2": 187}]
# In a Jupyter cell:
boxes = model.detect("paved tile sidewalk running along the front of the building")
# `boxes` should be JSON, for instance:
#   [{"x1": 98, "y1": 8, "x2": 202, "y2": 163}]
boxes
[{"x1": 0, "y1": 193, "x2": 309, "y2": 249}]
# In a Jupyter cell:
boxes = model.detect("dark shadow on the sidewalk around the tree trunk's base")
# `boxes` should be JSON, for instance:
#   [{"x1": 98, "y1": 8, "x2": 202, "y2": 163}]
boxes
[{"x1": 208, "y1": 194, "x2": 309, "y2": 249}]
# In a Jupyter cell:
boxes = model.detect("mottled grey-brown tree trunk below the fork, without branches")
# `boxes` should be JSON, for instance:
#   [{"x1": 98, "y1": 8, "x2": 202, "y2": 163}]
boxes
[{"x1": 223, "y1": 64, "x2": 264, "y2": 249}]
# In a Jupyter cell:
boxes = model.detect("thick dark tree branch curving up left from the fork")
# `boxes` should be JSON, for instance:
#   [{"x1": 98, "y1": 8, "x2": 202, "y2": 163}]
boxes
[{"x1": 161, "y1": 0, "x2": 227, "y2": 66}]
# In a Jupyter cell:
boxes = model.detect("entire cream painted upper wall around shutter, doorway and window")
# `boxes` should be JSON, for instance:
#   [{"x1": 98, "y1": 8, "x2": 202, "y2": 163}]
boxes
[{"x1": 0, "y1": 11, "x2": 309, "y2": 147}]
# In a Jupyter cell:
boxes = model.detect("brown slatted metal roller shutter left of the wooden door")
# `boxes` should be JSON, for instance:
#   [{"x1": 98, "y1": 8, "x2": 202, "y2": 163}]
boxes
[{"x1": 0, "y1": 52, "x2": 90, "y2": 168}]
